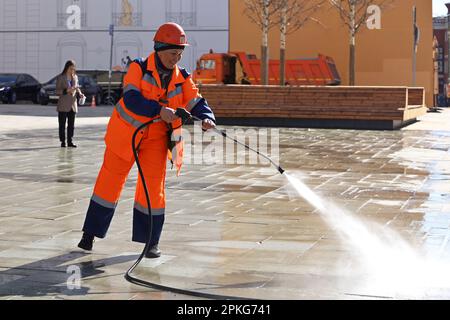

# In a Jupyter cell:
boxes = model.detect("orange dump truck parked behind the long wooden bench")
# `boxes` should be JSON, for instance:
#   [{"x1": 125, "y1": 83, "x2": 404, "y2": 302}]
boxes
[{"x1": 194, "y1": 52, "x2": 341, "y2": 86}]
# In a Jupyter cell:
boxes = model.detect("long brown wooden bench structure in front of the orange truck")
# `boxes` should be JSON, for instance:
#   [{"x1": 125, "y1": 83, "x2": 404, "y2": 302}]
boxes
[{"x1": 199, "y1": 85, "x2": 427, "y2": 129}]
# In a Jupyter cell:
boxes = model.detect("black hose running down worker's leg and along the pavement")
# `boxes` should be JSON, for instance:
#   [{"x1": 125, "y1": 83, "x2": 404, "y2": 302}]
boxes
[{"x1": 125, "y1": 120, "x2": 249, "y2": 300}]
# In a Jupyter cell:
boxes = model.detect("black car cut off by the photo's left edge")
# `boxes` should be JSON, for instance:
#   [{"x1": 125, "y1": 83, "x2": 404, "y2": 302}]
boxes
[{"x1": 0, "y1": 73, "x2": 42, "y2": 104}]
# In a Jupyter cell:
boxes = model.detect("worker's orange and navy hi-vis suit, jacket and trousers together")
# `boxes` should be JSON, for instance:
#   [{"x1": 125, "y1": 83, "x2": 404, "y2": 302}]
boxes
[{"x1": 83, "y1": 53, "x2": 204, "y2": 245}]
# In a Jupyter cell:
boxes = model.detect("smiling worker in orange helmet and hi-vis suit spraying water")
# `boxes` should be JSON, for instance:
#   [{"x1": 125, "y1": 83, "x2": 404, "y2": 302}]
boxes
[{"x1": 78, "y1": 23, "x2": 215, "y2": 258}]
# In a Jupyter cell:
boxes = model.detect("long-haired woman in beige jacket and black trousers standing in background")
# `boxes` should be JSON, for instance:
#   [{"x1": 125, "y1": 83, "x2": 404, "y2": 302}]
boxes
[{"x1": 56, "y1": 60, "x2": 84, "y2": 148}]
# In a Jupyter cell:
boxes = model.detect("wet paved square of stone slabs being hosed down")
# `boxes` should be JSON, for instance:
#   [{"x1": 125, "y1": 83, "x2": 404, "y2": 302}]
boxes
[{"x1": 0, "y1": 106, "x2": 450, "y2": 300}]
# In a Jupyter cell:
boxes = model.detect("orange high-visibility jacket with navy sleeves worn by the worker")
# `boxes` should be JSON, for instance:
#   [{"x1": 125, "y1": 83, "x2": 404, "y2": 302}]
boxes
[{"x1": 105, "y1": 53, "x2": 215, "y2": 164}]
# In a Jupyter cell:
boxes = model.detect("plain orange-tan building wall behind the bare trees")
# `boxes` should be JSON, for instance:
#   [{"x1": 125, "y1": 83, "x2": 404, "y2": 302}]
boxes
[{"x1": 230, "y1": 0, "x2": 434, "y2": 106}]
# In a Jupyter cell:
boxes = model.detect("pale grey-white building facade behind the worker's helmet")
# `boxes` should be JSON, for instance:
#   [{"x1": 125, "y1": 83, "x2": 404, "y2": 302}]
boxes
[{"x1": 0, "y1": 0, "x2": 229, "y2": 82}]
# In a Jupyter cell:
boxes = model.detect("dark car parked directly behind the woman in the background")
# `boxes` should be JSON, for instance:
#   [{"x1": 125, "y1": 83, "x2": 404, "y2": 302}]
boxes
[{"x1": 40, "y1": 74, "x2": 102, "y2": 105}]
